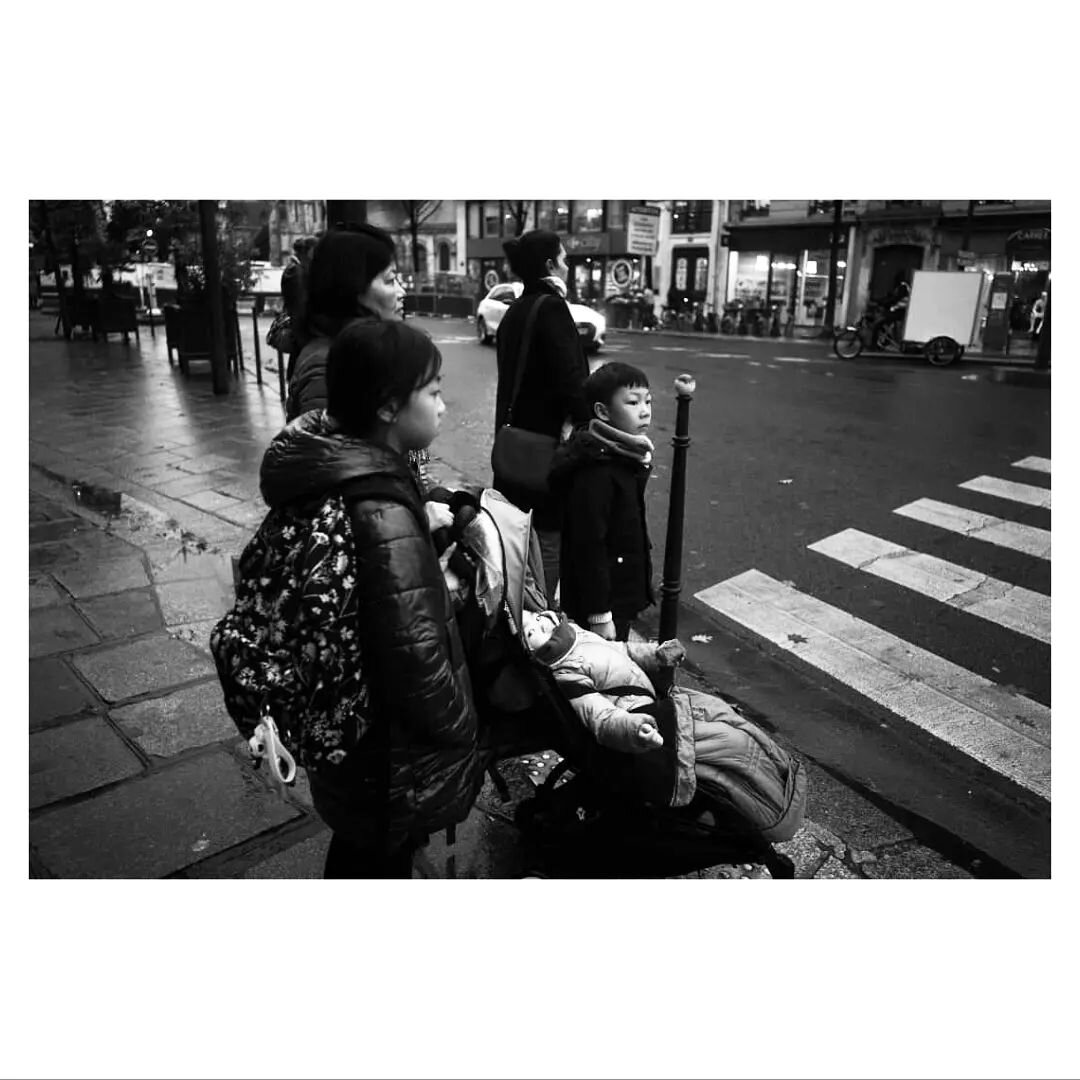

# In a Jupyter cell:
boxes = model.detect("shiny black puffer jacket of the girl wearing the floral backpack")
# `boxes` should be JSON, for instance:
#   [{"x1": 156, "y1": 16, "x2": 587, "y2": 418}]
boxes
[{"x1": 260, "y1": 411, "x2": 483, "y2": 845}]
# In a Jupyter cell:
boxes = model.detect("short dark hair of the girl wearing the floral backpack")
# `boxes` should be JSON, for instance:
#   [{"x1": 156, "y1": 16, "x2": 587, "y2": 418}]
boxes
[{"x1": 326, "y1": 319, "x2": 443, "y2": 436}]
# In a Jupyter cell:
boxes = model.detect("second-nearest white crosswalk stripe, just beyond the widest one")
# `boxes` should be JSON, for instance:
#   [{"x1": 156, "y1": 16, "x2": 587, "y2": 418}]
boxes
[{"x1": 807, "y1": 529, "x2": 1050, "y2": 645}]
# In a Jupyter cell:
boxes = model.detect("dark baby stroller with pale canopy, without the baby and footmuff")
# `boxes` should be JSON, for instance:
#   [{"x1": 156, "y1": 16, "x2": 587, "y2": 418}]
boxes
[{"x1": 445, "y1": 489, "x2": 795, "y2": 878}]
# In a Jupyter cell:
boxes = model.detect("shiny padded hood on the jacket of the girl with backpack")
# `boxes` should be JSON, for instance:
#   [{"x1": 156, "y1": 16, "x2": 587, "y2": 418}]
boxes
[{"x1": 259, "y1": 409, "x2": 419, "y2": 509}]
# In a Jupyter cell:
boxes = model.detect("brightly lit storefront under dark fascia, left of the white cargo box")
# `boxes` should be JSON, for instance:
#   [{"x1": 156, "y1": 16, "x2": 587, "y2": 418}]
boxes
[{"x1": 725, "y1": 225, "x2": 848, "y2": 326}]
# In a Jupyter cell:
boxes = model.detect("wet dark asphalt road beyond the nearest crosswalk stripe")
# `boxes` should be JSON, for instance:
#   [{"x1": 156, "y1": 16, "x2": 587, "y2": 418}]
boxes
[{"x1": 417, "y1": 320, "x2": 1050, "y2": 704}]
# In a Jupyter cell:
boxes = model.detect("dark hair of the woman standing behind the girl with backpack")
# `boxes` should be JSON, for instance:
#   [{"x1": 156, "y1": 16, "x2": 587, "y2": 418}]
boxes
[{"x1": 307, "y1": 225, "x2": 394, "y2": 319}]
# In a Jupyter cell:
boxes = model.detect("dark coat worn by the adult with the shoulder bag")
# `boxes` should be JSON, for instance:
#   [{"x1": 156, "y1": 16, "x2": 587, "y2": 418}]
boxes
[{"x1": 495, "y1": 281, "x2": 591, "y2": 529}]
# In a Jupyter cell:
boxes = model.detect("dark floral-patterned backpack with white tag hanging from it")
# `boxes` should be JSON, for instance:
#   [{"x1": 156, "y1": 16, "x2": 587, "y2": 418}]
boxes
[{"x1": 210, "y1": 488, "x2": 380, "y2": 783}]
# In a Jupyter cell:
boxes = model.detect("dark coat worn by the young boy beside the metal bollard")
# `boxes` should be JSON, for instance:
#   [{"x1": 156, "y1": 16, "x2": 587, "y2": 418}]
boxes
[{"x1": 549, "y1": 429, "x2": 654, "y2": 629}]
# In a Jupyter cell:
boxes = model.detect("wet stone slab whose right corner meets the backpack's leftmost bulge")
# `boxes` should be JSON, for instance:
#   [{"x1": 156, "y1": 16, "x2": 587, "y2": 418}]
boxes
[{"x1": 71, "y1": 634, "x2": 216, "y2": 702}]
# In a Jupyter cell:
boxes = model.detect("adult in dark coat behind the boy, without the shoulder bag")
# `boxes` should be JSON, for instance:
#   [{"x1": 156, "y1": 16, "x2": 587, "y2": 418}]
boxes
[{"x1": 494, "y1": 229, "x2": 591, "y2": 604}]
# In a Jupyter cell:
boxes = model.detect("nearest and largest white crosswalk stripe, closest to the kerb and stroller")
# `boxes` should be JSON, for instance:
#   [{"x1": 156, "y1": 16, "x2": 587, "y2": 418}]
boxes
[{"x1": 696, "y1": 570, "x2": 1050, "y2": 802}]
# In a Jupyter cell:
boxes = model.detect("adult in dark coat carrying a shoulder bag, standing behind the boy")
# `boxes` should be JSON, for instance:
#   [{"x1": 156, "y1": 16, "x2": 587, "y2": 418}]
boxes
[{"x1": 491, "y1": 229, "x2": 590, "y2": 604}]
